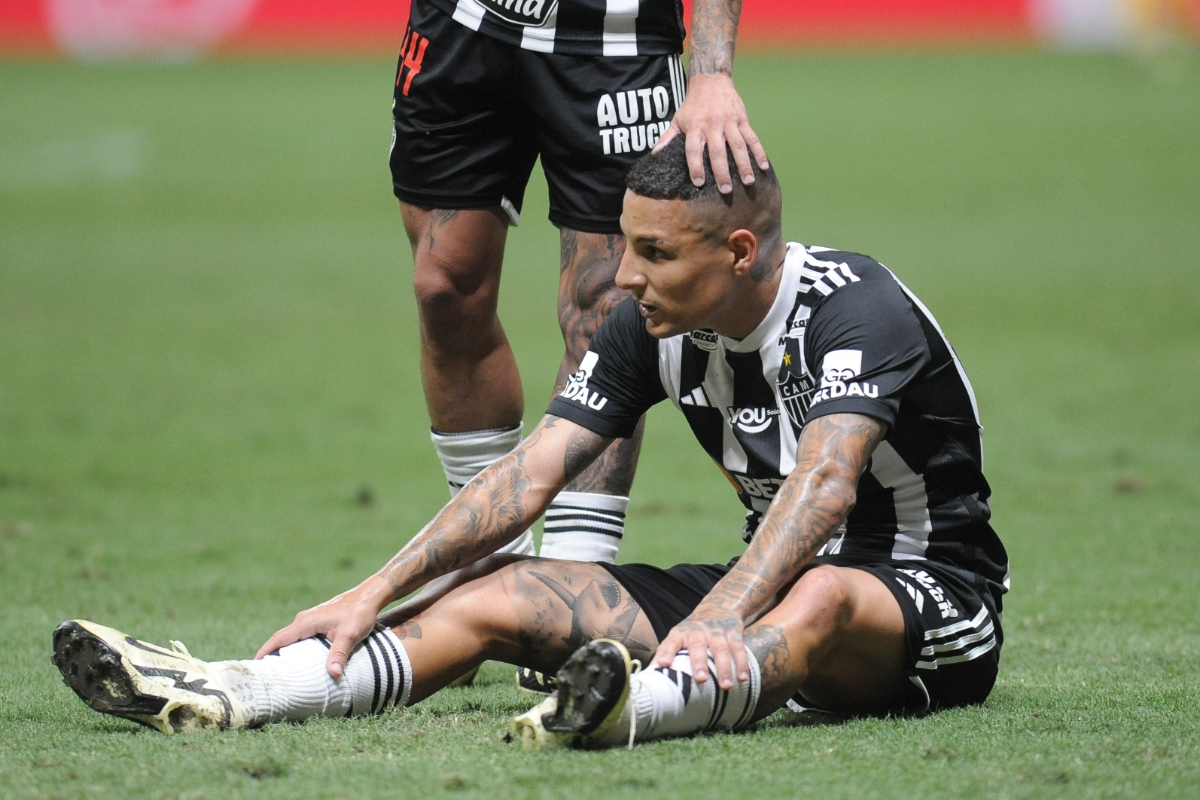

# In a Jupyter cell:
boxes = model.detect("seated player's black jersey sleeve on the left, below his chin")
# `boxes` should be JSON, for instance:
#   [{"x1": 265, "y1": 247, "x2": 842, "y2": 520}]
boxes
[{"x1": 547, "y1": 299, "x2": 666, "y2": 439}]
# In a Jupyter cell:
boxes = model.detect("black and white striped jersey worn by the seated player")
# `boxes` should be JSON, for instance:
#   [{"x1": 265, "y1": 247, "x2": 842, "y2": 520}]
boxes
[{"x1": 550, "y1": 243, "x2": 1008, "y2": 604}]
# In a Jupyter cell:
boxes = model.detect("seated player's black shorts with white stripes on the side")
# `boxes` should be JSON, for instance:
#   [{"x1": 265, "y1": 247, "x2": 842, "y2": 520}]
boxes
[{"x1": 600, "y1": 561, "x2": 1003, "y2": 712}]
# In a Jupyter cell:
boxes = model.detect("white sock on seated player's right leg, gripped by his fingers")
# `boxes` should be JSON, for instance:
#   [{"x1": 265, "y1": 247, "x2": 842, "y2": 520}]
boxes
[{"x1": 608, "y1": 650, "x2": 762, "y2": 745}]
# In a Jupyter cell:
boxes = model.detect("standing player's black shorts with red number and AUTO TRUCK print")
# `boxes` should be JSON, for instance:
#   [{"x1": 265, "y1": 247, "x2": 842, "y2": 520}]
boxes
[{"x1": 389, "y1": 4, "x2": 686, "y2": 234}]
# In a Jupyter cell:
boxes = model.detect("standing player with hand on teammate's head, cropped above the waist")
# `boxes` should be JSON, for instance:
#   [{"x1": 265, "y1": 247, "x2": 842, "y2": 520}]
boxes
[{"x1": 390, "y1": 0, "x2": 767, "y2": 561}]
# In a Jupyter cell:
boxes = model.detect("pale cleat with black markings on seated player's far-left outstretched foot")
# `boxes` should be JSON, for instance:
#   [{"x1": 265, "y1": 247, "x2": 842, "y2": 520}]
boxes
[{"x1": 52, "y1": 620, "x2": 250, "y2": 734}]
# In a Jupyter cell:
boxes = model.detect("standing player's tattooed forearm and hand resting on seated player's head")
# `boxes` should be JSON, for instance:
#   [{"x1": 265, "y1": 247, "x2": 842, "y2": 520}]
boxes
[{"x1": 654, "y1": 0, "x2": 768, "y2": 193}]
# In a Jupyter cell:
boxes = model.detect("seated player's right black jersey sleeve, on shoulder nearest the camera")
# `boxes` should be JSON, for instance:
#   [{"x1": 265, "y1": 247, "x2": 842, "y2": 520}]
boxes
[{"x1": 804, "y1": 277, "x2": 930, "y2": 427}]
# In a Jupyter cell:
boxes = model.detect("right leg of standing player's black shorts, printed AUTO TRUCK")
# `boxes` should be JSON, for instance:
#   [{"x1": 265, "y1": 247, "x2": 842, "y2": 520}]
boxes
[{"x1": 521, "y1": 53, "x2": 686, "y2": 234}]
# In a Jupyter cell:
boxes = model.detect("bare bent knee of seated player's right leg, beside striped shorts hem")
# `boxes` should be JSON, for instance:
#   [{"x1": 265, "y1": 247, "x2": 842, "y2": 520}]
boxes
[{"x1": 744, "y1": 566, "x2": 912, "y2": 718}]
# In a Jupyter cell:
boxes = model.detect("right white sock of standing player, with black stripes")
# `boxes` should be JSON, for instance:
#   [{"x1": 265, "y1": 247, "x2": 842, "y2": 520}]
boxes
[{"x1": 538, "y1": 492, "x2": 629, "y2": 564}]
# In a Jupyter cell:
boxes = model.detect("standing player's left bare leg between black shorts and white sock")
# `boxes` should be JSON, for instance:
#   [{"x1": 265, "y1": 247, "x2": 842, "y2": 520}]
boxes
[{"x1": 401, "y1": 203, "x2": 524, "y2": 433}]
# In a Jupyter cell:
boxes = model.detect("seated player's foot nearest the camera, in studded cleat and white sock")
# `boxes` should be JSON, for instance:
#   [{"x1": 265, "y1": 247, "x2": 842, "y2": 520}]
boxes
[{"x1": 509, "y1": 639, "x2": 762, "y2": 750}]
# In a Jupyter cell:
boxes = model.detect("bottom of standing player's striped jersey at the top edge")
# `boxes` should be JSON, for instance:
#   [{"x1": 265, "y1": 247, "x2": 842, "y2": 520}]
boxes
[{"x1": 422, "y1": 0, "x2": 684, "y2": 55}]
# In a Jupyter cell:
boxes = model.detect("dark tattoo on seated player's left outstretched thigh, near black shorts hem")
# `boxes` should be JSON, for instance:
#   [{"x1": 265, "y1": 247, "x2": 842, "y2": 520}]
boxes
[{"x1": 515, "y1": 563, "x2": 653, "y2": 660}]
